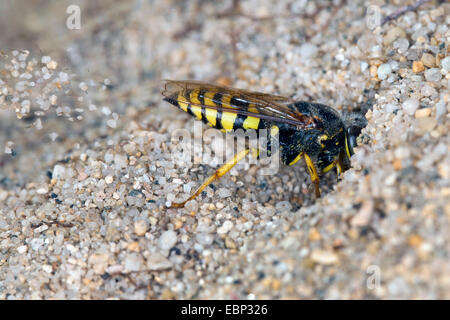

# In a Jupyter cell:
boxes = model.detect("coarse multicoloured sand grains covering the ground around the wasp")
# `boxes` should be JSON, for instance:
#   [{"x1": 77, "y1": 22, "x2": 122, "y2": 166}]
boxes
[{"x1": 0, "y1": 0, "x2": 450, "y2": 299}]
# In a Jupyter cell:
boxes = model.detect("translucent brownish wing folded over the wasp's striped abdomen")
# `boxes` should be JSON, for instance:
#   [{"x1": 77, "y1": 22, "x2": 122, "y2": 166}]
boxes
[{"x1": 162, "y1": 80, "x2": 320, "y2": 129}]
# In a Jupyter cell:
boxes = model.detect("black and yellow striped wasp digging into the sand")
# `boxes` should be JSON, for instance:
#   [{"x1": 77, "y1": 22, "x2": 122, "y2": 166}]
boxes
[{"x1": 162, "y1": 80, "x2": 365, "y2": 208}]
